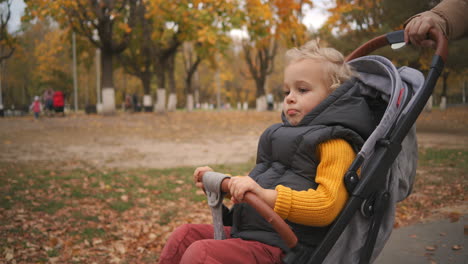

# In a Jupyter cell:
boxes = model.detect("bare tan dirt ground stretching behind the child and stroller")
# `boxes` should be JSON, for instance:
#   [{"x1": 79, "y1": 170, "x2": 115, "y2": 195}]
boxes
[{"x1": 0, "y1": 107, "x2": 468, "y2": 168}]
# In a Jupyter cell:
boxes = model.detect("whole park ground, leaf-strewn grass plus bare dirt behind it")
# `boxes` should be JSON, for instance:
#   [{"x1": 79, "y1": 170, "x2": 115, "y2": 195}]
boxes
[{"x1": 0, "y1": 108, "x2": 468, "y2": 263}]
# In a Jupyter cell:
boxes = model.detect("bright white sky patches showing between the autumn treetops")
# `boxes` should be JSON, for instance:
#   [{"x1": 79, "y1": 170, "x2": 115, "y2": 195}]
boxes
[{"x1": 8, "y1": 0, "x2": 330, "y2": 32}]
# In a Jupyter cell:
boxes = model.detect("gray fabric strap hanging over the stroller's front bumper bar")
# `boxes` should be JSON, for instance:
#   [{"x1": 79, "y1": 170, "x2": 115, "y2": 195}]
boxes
[{"x1": 203, "y1": 171, "x2": 229, "y2": 240}]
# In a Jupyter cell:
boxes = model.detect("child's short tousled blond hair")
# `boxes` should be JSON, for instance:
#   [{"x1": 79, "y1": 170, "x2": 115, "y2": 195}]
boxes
[{"x1": 285, "y1": 39, "x2": 355, "y2": 90}]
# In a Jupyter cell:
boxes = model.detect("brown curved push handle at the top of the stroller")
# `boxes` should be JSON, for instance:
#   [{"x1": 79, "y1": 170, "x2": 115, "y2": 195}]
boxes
[{"x1": 346, "y1": 28, "x2": 448, "y2": 62}]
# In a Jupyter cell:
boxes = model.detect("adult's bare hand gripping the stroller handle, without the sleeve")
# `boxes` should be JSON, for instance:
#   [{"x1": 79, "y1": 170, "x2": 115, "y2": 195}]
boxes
[{"x1": 405, "y1": 11, "x2": 445, "y2": 49}]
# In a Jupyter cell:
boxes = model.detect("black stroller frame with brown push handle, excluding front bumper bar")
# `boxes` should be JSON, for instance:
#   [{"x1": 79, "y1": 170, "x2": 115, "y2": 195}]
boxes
[{"x1": 306, "y1": 30, "x2": 448, "y2": 264}]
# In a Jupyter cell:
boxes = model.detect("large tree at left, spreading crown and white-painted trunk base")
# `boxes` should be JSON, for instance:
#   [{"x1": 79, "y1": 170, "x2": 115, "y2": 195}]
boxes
[{"x1": 26, "y1": 0, "x2": 137, "y2": 114}]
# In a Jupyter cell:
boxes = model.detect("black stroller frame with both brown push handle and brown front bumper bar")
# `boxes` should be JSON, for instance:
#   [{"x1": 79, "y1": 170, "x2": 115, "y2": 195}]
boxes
[{"x1": 200, "y1": 29, "x2": 448, "y2": 264}]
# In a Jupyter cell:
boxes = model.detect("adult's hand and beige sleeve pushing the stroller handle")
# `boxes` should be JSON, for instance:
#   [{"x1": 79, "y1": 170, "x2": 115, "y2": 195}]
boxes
[{"x1": 405, "y1": 0, "x2": 468, "y2": 48}]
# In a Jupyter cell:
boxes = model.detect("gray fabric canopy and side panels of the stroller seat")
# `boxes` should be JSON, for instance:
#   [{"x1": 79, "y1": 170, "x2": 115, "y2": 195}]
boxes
[{"x1": 324, "y1": 56, "x2": 424, "y2": 264}]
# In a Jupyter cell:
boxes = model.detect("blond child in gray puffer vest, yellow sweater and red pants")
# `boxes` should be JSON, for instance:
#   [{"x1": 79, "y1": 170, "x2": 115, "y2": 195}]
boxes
[{"x1": 160, "y1": 41, "x2": 375, "y2": 263}]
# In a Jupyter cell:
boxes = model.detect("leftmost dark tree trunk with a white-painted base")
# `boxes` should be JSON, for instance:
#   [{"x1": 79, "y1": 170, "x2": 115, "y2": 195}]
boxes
[{"x1": 101, "y1": 50, "x2": 115, "y2": 115}]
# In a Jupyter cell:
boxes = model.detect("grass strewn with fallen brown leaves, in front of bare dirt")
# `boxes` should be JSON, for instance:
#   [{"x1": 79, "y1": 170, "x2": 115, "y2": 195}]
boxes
[{"x1": 0, "y1": 148, "x2": 468, "y2": 263}]
